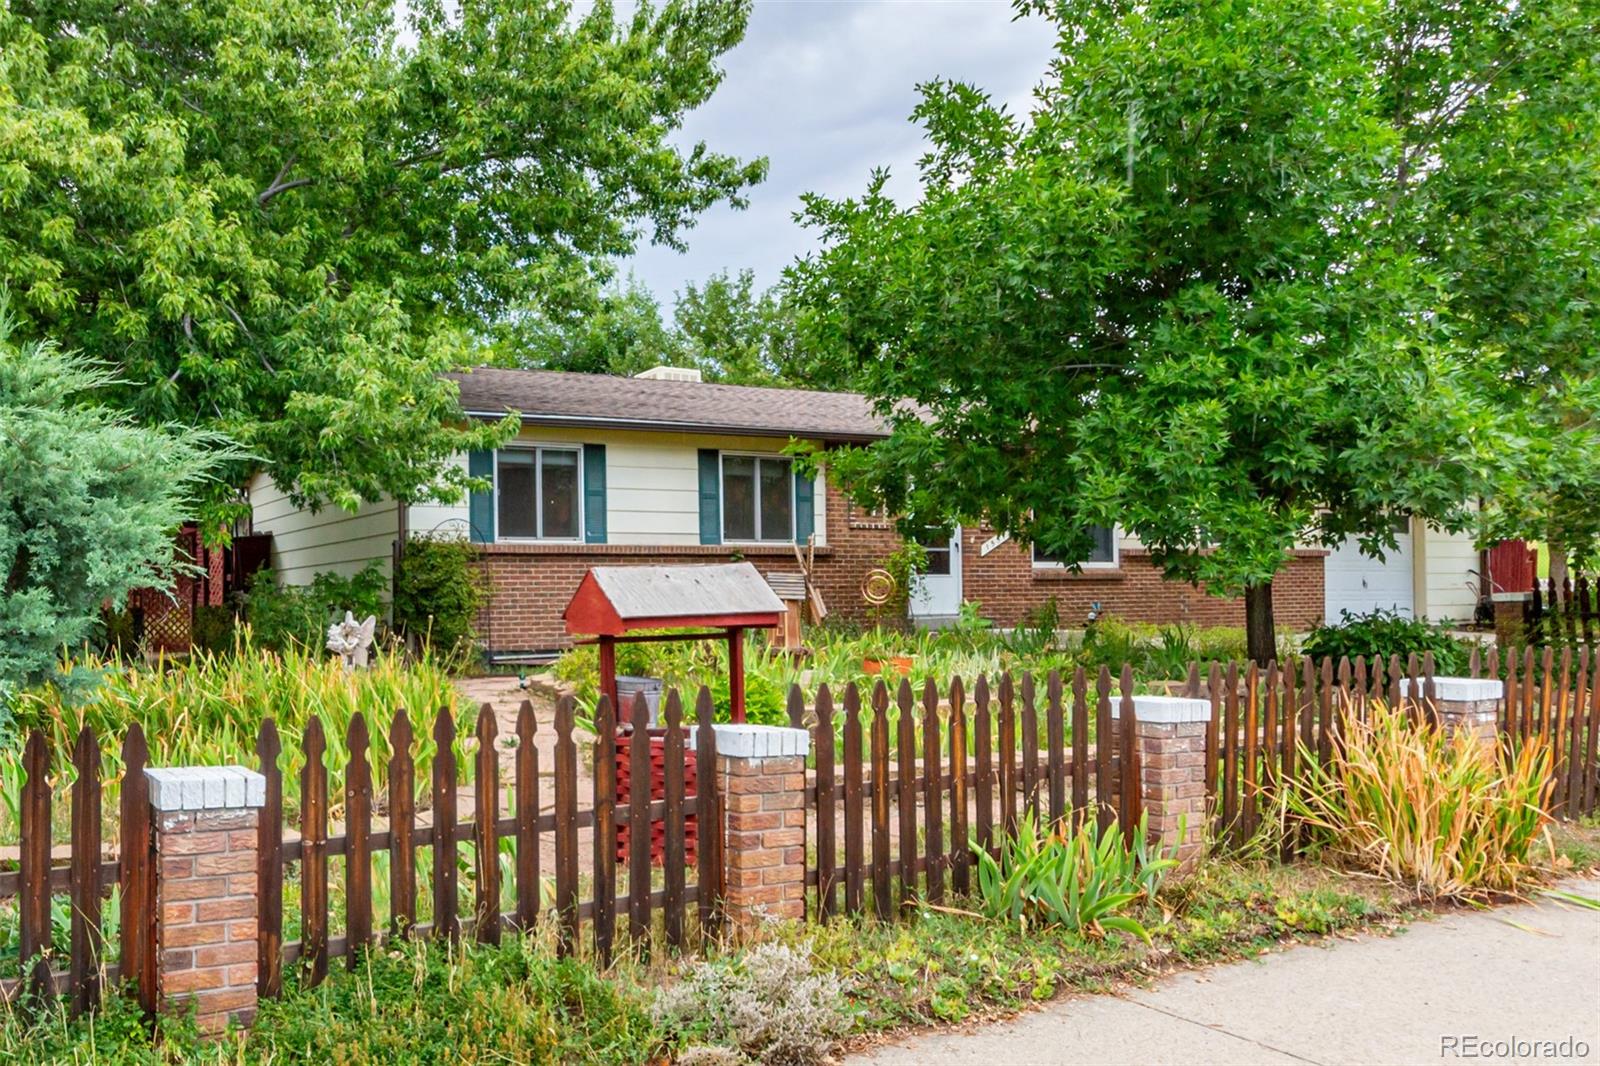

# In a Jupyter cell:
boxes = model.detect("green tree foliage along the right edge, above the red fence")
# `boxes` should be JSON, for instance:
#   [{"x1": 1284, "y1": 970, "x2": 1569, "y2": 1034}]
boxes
[{"x1": 1381, "y1": 0, "x2": 1600, "y2": 560}]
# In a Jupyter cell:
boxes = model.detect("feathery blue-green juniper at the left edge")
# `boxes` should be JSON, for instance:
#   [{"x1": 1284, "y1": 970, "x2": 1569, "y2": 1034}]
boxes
[{"x1": 0, "y1": 302, "x2": 234, "y2": 694}]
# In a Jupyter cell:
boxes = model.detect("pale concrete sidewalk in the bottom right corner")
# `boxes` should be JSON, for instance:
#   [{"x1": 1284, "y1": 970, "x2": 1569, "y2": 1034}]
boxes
[{"x1": 851, "y1": 880, "x2": 1600, "y2": 1066}]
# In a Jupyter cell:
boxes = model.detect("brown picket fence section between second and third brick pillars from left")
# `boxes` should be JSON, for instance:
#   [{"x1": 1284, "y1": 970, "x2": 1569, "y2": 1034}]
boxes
[{"x1": 789, "y1": 669, "x2": 1141, "y2": 919}]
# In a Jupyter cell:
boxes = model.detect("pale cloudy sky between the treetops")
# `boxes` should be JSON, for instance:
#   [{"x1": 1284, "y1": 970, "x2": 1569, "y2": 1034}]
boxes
[{"x1": 622, "y1": 0, "x2": 1054, "y2": 306}]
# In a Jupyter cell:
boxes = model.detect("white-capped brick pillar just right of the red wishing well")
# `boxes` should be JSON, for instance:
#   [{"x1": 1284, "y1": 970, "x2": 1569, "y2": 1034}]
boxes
[{"x1": 717, "y1": 725, "x2": 811, "y2": 927}]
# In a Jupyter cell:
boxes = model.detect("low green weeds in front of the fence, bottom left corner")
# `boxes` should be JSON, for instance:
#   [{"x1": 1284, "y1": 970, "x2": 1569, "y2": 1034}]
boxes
[{"x1": 0, "y1": 936, "x2": 666, "y2": 1064}]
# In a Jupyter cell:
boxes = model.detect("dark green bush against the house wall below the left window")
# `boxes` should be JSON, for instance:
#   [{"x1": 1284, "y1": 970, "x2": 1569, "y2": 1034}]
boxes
[{"x1": 394, "y1": 536, "x2": 488, "y2": 656}]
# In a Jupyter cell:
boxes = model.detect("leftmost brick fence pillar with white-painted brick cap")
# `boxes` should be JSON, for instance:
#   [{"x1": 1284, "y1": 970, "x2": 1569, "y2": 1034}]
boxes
[{"x1": 144, "y1": 767, "x2": 267, "y2": 1032}]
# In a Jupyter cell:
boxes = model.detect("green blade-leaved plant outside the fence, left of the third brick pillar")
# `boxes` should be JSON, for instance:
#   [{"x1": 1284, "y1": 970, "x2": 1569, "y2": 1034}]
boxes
[{"x1": 973, "y1": 813, "x2": 1178, "y2": 941}]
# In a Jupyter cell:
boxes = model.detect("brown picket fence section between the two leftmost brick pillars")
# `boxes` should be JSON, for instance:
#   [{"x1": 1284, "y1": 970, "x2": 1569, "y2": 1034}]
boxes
[{"x1": 256, "y1": 688, "x2": 722, "y2": 996}]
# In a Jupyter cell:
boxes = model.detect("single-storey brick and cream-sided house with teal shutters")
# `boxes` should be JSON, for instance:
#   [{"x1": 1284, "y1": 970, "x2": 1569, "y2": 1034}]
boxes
[{"x1": 250, "y1": 368, "x2": 1477, "y2": 656}]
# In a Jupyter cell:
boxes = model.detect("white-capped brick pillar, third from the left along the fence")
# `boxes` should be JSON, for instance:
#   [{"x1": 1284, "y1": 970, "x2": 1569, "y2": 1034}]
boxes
[{"x1": 1110, "y1": 696, "x2": 1211, "y2": 863}]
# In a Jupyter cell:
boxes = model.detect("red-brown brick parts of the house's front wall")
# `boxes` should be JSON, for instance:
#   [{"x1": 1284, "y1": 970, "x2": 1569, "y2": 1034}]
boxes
[{"x1": 478, "y1": 485, "x2": 1326, "y2": 651}]
